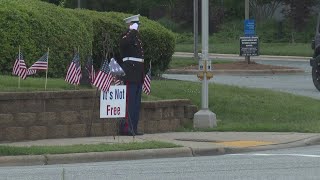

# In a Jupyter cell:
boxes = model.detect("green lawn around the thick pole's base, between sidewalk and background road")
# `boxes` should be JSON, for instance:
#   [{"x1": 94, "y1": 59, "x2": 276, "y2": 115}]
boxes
[{"x1": 152, "y1": 80, "x2": 320, "y2": 132}]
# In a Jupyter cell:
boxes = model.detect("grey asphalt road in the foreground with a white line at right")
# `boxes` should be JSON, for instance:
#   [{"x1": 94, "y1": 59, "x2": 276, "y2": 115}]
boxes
[{"x1": 0, "y1": 145, "x2": 320, "y2": 180}]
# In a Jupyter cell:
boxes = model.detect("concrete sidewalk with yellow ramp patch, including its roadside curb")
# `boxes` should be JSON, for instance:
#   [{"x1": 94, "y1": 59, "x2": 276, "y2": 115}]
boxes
[{"x1": 0, "y1": 132, "x2": 320, "y2": 166}]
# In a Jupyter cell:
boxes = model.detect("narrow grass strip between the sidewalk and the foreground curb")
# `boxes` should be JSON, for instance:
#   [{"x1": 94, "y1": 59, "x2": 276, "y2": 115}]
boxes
[{"x1": 0, "y1": 141, "x2": 181, "y2": 156}]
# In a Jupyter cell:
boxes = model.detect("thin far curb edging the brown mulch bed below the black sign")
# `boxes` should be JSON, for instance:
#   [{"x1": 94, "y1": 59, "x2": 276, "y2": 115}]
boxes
[{"x1": 165, "y1": 69, "x2": 304, "y2": 75}]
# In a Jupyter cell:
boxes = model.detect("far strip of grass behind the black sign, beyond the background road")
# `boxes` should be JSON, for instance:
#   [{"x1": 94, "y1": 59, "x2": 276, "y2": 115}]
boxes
[{"x1": 175, "y1": 41, "x2": 313, "y2": 57}]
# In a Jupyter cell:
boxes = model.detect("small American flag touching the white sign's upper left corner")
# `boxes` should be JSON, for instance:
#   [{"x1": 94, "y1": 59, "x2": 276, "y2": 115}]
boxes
[{"x1": 93, "y1": 59, "x2": 113, "y2": 92}]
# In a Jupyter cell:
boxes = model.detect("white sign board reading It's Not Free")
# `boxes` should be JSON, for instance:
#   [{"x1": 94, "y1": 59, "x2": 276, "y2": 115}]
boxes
[{"x1": 100, "y1": 85, "x2": 126, "y2": 118}]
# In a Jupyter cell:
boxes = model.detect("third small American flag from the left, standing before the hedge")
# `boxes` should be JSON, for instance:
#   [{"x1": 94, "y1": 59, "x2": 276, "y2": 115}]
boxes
[{"x1": 65, "y1": 53, "x2": 81, "y2": 85}]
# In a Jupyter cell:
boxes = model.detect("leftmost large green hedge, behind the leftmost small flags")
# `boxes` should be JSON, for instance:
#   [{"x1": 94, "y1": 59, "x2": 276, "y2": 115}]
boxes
[{"x1": 0, "y1": 0, "x2": 93, "y2": 77}]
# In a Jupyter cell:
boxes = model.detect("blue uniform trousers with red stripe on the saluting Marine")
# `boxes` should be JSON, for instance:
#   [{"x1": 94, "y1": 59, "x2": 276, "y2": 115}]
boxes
[{"x1": 124, "y1": 82, "x2": 142, "y2": 132}]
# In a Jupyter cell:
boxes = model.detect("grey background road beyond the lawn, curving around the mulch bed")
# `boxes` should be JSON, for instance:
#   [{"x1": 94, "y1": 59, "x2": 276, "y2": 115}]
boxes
[{"x1": 163, "y1": 59, "x2": 320, "y2": 99}]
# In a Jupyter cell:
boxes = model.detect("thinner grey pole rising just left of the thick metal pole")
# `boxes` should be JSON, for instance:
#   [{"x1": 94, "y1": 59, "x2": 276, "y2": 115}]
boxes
[{"x1": 193, "y1": 0, "x2": 199, "y2": 61}]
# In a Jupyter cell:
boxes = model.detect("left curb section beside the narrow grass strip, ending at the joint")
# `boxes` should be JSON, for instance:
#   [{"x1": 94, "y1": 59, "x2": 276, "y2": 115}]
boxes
[{"x1": 0, "y1": 147, "x2": 193, "y2": 167}]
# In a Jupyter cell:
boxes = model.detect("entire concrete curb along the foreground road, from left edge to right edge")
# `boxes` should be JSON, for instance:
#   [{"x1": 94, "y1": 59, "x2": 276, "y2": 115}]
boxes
[{"x1": 0, "y1": 135, "x2": 320, "y2": 167}]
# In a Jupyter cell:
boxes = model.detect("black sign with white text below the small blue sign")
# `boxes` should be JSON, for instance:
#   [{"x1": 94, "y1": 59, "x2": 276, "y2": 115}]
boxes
[{"x1": 240, "y1": 36, "x2": 259, "y2": 56}]
